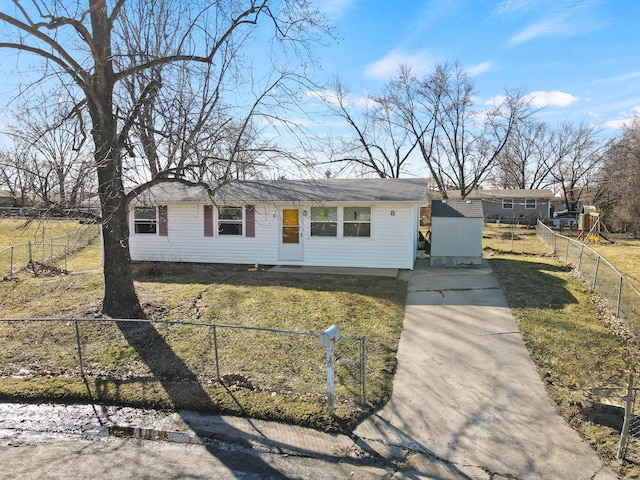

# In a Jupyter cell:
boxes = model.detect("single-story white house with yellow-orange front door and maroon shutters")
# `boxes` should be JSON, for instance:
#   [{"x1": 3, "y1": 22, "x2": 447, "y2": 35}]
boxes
[{"x1": 129, "y1": 179, "x2": 427, "y2": 269}]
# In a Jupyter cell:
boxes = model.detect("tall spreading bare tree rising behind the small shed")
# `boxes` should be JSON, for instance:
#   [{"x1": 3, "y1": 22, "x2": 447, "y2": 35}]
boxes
[{"x1": 380, "y1": 63, "x2": 531, "y2": 198}]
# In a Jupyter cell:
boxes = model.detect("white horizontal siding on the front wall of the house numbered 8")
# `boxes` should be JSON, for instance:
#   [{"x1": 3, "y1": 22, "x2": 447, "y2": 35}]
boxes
[{"x1": 130, "y1": 203, "x2": 419, "y2": 269}]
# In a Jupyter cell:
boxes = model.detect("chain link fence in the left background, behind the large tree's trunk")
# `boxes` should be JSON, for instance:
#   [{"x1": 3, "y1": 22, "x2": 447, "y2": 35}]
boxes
[{"x1": 0, "y1": 225, "x2": 99, "y2": 278}]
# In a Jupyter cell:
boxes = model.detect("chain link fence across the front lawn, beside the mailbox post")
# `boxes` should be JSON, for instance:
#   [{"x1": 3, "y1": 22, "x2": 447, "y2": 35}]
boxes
[{"x1": 0, "y1": 319, "x2": 367, "y2": 411}]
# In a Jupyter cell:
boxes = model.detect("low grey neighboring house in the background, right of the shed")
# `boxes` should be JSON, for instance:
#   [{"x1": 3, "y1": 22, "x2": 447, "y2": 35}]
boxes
[{"x1": 447, "y1": 189, "x2": 553, "y2": 222}]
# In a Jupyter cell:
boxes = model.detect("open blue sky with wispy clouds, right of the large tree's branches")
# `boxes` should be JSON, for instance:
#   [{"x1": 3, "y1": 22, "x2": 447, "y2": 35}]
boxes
[{"x1": 317, "y1": 0, "x2": 640, "y2": 129}]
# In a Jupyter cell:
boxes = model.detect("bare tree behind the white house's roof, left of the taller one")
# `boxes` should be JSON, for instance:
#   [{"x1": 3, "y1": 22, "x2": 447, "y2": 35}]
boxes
[{"x1": 322, "y1": 77, "x2": 417, "y2": 178}]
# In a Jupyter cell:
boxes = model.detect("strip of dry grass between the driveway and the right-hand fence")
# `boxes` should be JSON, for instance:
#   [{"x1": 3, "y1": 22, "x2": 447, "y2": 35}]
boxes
[{"x1": 485, "y1": 229, "x2": 640, "y2": 478}]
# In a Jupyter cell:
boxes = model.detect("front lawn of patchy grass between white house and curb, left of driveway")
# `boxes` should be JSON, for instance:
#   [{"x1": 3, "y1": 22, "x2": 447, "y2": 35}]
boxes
[{"x1": 0, "y1": 256, "x2": 407, "y2": 431}]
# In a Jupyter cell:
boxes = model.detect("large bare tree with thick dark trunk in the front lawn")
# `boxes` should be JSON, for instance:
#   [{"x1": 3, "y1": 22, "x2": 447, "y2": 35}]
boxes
[{"x1": 0, "y1": 0, "x2": 322, "y2": 318}]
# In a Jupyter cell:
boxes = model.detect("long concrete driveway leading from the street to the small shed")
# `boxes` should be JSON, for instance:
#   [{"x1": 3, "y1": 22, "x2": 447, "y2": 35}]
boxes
[{"x1": 355, "y1": 261, "x2": 616, "y2": 480}]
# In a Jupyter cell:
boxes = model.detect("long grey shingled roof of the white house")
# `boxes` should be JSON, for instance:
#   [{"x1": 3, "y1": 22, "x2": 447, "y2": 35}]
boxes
[{"x1": 131, "y1": 178, "x2": 428, "y2": 205}]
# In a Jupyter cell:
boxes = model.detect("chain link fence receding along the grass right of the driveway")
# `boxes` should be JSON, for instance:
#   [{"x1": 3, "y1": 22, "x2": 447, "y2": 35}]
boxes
[{"x1": 536, "y1": 222, "x2": 640, "y2": 338}]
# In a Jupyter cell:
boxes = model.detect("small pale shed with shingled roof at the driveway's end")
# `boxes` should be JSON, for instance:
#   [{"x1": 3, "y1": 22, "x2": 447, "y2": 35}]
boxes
[{"x1": 431, "y1": 200, "x2": 484, "y2": 266}]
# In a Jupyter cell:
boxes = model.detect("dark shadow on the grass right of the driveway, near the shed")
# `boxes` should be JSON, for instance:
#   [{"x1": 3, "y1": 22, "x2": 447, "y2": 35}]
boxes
[{"x1": 489, "y1": 258, "x2": 578, "y2": 310}]
